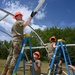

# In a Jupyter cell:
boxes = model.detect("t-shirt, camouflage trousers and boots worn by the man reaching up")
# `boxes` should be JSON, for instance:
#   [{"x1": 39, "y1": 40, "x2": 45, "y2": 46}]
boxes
[{"x1": 1, "y1": 20, "x2": 24, "y2": 75}]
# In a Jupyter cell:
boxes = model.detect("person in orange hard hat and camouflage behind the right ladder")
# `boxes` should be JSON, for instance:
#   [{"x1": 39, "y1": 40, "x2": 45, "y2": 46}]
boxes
[{"x1": 44, "y1": 36, "x2": 62, "y2": 75}]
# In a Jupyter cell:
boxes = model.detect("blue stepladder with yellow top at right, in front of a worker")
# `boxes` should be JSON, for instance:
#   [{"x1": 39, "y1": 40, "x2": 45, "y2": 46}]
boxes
[{"x1": 47, "y1": 39, "x2": 75, "y2": 75}]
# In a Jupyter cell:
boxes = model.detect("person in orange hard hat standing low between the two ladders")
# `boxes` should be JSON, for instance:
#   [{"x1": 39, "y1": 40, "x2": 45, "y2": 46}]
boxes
[{"x1": 30, "y1": 51, "x2": 42, "y2": 75}]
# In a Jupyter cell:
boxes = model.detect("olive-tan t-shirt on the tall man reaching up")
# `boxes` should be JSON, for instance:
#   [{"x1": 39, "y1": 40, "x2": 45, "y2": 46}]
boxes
[{"x1": 12, "y1": 20, "x2": 24, "y2": 36}]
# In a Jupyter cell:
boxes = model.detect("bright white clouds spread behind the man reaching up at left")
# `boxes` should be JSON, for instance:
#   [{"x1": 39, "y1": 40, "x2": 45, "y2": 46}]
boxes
[{"x1": 0, "y1": 0, "x2": 46, "y2": 40}]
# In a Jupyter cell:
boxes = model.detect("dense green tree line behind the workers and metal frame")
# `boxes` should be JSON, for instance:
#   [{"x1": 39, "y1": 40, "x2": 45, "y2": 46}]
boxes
[{"x1": 0, "y1": 27, "x2": 75, "y2": 63}]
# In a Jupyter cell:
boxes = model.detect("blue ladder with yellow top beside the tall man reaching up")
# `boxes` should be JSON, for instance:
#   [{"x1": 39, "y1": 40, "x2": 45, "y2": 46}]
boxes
[{"x1": 12, "y1": 34, "x2": 34, "y2": 75}]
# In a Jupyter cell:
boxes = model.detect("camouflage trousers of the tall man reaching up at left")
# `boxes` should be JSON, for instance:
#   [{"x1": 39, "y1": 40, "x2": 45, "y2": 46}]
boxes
[{"x1": 5, "y1": 37, "x2": 22, "y2": 68}]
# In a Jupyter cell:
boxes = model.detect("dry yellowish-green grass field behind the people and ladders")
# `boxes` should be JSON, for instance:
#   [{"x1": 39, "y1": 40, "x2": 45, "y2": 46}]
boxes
[{"x1": 0, "y1": 59, "x2": 73, "y2": 75}]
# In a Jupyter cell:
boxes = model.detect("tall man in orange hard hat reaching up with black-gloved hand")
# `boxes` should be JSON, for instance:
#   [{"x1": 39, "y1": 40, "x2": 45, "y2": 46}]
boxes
[{"x1": 1, "y1": 12, "x2": 36, "y2": 75}]
